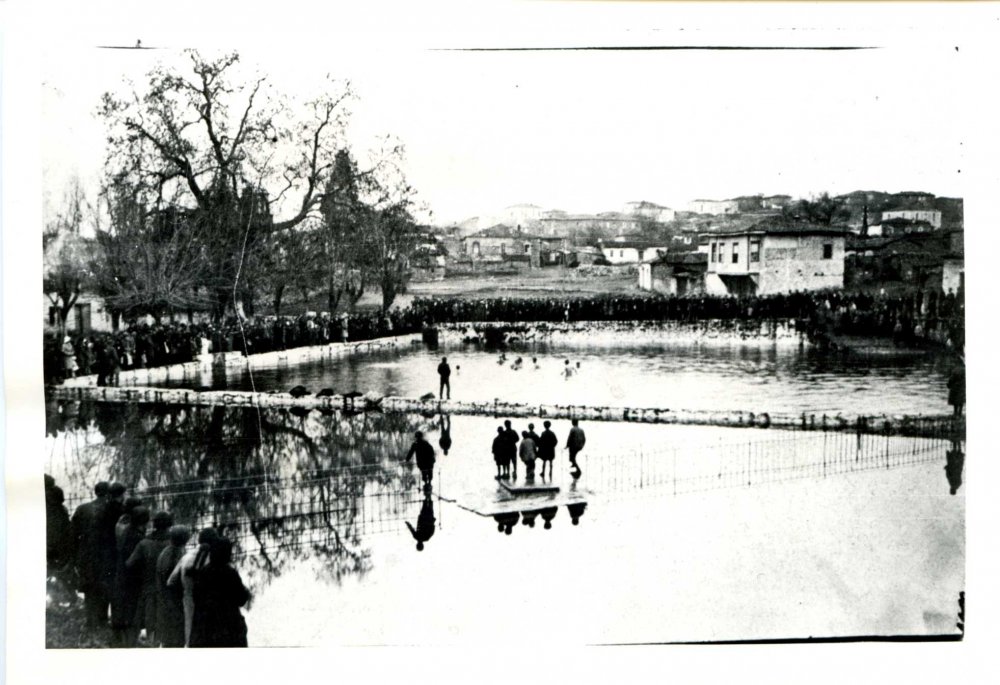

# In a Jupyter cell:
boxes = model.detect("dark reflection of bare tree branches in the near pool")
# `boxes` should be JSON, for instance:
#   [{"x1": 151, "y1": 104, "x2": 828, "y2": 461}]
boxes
[{"x1": 46, "y1": 402, "x2": 427, "y2": 589}]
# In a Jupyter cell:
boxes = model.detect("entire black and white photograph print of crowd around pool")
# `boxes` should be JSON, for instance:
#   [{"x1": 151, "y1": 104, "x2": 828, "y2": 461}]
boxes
[{"x1": 5, "y1": 3, "x2": 996, "y2": 678}]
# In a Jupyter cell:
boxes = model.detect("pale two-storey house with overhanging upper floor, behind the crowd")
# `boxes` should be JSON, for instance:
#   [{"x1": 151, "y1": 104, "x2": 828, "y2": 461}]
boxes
[{"x1": 705, "y1": 217, "x2": 848, "y2": 295}]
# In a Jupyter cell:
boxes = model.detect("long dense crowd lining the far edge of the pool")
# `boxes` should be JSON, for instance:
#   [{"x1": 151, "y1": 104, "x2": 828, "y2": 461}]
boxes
[{"x1": 45, "y1": 290, "x2": 965, "y2": 385}]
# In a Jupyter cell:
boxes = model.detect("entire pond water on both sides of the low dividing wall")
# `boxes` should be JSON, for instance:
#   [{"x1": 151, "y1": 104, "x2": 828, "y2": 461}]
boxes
[{"x1": 46, "y1": 345, "x2": 965, "y2": 646}]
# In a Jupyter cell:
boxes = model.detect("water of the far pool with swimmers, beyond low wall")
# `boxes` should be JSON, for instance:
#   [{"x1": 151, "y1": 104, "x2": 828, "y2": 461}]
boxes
[{"x1": 160, "y1": 343, "x2": 950, "y2": 414}]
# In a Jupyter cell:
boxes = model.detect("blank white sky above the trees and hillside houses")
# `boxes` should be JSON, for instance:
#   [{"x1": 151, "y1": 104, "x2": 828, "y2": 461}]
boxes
[{"x1": 42, "y1": 19, "x2": 963, "y2": 222}]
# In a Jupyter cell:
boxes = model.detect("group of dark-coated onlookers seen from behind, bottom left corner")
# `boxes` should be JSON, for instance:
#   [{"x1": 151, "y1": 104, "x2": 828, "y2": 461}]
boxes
[{"x1": 45, "y1": 475, "x2": 250, "y2": 647}]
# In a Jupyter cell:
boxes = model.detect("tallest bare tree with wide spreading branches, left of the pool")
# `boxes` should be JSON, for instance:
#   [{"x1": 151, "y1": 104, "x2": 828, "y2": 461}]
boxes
[{"x1": 101, "y1": 51, "x2": 351, "y2": 316}]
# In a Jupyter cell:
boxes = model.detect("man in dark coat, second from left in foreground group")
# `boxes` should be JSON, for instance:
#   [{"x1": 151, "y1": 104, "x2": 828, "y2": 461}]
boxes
[{"x1": 70, "y1": 480, "x2": 110, "y2": 628}]
